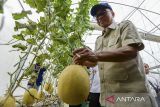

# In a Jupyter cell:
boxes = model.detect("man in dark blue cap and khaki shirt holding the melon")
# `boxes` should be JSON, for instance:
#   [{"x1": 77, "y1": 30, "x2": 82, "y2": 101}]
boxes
[{"x1": 73, "y1": 3, "x2": 156, "y2": 107}]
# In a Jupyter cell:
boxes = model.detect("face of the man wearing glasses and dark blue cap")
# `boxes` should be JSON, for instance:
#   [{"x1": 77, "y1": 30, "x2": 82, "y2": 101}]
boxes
[{"x1": 95, "y1": 9, "x2": 114, "y2": 28}]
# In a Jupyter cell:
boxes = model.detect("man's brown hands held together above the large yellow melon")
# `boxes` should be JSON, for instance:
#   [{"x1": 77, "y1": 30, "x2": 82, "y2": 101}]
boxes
[{"x1": 73, "y1": 48, "x2": 98, "y2": 67}]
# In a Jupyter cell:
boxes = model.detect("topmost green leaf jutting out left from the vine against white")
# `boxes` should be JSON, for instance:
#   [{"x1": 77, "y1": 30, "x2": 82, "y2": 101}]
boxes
[{"x1": 12, "y1": 11, "x2": 32, "y2": 20}]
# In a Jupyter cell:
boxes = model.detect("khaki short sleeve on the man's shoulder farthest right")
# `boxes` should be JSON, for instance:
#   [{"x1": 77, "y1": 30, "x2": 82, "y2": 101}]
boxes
[{"x1": 121, "y1": 21, "x2": 143, "y2": 46}]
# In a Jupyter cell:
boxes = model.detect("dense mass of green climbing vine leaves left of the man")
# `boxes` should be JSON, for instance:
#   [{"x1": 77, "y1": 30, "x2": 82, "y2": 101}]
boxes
[{"x1": 10, "y1": 0, "x2": 97, "y2": 83}]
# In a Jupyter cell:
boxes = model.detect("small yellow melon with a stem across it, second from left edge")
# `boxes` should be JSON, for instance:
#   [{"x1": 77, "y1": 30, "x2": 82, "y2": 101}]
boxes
[{"x1": 22, "y1": 88, "x2": 38, "y2": 106}]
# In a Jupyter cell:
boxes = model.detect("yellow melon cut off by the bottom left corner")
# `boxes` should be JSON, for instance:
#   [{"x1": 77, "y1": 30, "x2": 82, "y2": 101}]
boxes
[{"x1": 0, "y1": 96, "x2": 16, "y2": 107}]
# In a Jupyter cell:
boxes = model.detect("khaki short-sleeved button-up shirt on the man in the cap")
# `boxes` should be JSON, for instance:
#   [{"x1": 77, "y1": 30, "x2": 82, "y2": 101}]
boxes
[{"x1": 95, "y1": 21, "x2": 155, "y2": 107}]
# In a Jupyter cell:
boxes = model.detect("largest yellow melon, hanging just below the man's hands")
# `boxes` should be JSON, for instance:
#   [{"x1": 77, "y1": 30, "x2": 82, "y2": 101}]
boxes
[{"x1": 58, "y1": 65, "x2": 90, "y2": 105}]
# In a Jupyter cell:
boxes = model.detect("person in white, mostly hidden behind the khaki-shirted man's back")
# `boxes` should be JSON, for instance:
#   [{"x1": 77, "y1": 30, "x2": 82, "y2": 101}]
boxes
[{"x1": 144, "y1": 63, "x2": 160, "y2": 107}]
